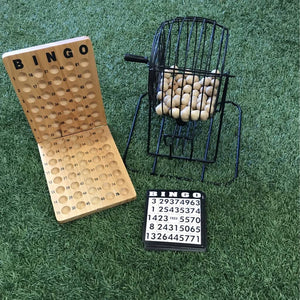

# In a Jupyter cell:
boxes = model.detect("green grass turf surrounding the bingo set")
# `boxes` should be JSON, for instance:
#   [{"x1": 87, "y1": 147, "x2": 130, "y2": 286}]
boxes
[{"x1": 0, "y1": 0, "x2": 299, "y2": 300}]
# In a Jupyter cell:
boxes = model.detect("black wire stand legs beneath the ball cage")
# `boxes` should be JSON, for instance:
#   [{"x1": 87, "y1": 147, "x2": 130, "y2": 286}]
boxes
[{"x1": 123, "y1": 93, "x2": 242, "y2": 185}]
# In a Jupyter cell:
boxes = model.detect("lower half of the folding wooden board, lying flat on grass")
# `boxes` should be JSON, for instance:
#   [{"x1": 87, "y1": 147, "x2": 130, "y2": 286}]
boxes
[{"x1": 39, "y1": 126, "x2": 135, "y2": 220}]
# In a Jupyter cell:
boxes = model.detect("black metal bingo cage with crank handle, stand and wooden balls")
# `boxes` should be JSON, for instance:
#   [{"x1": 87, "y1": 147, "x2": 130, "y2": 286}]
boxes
[{"x1": 123, "y1": 17, "x2": 242, "y2": 184}]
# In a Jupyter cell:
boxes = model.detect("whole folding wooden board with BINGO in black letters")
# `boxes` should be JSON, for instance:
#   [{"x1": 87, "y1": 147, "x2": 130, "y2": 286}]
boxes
[{"x1": 2, "y1": 37, "x2": 136, "y2": 223}]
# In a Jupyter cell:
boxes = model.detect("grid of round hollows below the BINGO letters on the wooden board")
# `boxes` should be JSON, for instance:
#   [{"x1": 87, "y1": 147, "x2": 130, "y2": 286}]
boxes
[{"x1": 16, "y1": 49, "x2": 103, "y2": 141}]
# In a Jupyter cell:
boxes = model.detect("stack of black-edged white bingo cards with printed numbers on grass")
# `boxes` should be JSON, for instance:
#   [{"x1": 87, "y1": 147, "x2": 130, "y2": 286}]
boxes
[{"x1": 143, "y1": 190, "x2": 206, "y2": 251}]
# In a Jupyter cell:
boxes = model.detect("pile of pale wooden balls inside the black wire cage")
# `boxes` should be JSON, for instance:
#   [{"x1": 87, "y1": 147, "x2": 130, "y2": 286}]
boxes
[{"x1": 155, "y1": 66, "x2": 220, "y2": 122}]
